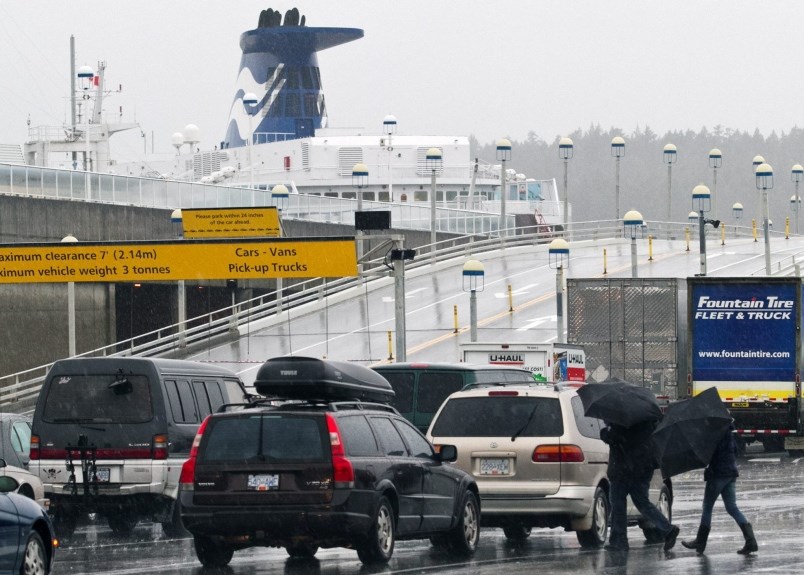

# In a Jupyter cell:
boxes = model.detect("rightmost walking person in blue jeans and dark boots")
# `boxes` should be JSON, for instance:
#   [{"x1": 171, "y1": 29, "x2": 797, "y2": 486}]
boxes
[{"x1": 681, "y1": 423, "x2": 759, "y2": 555}]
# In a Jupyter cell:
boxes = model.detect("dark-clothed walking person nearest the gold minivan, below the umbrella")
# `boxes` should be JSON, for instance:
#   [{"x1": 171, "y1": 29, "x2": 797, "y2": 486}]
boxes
[{"x1": 600, "y1": 420, "x2": 679, "y2": 551}]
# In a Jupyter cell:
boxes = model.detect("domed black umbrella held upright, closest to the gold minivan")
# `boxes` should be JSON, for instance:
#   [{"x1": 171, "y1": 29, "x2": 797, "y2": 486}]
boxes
[{"x1": 578, "y1": 381, "x2": 662, "y2": 427}]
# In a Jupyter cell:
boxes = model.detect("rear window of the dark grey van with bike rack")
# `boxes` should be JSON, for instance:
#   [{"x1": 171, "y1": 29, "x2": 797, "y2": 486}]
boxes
[{"x1": 42, "y1": 374, "x2": 153, "y2": 423}]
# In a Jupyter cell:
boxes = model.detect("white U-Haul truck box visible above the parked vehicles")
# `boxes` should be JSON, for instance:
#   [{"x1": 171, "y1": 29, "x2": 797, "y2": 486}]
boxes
[{"x1": 461, "y1": 342, "x2": 586, "y2": 382}]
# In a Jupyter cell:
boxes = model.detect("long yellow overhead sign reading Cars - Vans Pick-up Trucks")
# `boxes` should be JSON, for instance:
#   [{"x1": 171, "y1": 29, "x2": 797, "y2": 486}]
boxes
[{"x1": 0, "y1": 238, "x2": 357, "y2": 283}]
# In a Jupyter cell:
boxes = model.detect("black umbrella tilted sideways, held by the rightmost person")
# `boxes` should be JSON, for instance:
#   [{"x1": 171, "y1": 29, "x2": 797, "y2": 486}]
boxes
[{"x1": 653, "y1": 387, "x2": 731, "y2": 477}]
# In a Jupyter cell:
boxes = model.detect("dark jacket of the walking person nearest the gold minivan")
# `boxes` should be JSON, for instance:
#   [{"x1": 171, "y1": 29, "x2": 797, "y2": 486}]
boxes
[{"x1": 600, "y1": 421, "x2": 658, "y2": 481}]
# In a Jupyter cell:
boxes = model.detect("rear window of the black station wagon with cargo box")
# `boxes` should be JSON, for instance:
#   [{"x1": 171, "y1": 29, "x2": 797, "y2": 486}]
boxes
[{"x1": 199, "y1": 414, "x2": 329, "y2": 462}]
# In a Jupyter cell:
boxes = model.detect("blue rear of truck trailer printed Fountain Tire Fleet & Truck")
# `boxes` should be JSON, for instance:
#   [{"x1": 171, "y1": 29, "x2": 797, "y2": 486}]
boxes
[{"x1": 687, "y1": 277, "x2": 804, "y2": 451}]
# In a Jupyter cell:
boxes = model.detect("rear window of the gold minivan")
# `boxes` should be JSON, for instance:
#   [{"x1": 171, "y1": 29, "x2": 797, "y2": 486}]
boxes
[{"x1": 432, "y1": 396, "x2": 564, "y2": 437}]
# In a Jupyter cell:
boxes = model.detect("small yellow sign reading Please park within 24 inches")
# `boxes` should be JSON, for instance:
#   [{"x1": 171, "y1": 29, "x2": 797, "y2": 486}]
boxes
[{"x1": 181, "y1": 206, "x2": 281, "y2": 238}]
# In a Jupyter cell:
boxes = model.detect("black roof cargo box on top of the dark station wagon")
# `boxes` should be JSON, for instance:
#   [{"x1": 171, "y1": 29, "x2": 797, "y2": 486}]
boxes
[{"x1": 254, "y1": 356, "x2": 394, "y2": 403}]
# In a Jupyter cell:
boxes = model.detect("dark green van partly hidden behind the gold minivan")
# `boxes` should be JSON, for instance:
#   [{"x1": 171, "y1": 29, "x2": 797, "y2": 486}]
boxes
[{"x1": 372, "y1": 362, "x2": 533, "y2": 433}]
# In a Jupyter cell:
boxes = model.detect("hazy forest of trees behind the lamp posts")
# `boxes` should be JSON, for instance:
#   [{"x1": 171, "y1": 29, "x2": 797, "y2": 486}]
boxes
[{"x1": 471, "y1": 125, "x2": 804, "y2": 233}]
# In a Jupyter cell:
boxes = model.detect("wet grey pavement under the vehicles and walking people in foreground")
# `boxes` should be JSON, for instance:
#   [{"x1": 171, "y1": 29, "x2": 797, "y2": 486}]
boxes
[{"x1": 54, "y1": 446, "x2": 804, "y2": 575}]
